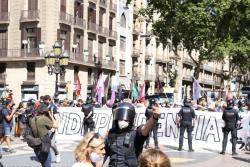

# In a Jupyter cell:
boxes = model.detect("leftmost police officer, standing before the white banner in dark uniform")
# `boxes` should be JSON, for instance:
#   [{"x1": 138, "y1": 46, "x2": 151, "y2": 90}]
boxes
[{"x1": 82, "y1": 96, "x2": 95, "y2": 134}]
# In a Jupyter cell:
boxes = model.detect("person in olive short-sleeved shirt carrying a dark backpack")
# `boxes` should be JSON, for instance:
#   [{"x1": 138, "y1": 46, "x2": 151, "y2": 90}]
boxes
[{"x1": 30, "y1": 104, "x2": 58, "y2": 167}]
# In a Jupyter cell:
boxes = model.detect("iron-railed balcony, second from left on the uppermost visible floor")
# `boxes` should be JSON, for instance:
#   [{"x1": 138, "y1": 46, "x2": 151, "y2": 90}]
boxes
[{"x1": 20, "y1": 10, "x2": 40, "y2": 22}]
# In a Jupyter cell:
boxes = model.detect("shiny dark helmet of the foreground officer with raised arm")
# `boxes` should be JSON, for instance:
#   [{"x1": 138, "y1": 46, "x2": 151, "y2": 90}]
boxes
[{"x1": 114, "y1": 102, "x2": 135, "y2": 125}]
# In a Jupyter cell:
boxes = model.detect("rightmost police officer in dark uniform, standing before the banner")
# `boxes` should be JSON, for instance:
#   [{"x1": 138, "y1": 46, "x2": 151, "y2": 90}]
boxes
[{"x1": 220, "y1": 99, "x2": 240, "y2": 155}]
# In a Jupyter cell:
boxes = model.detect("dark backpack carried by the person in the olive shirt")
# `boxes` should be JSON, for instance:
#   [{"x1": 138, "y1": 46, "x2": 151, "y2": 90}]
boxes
[{"x1": 23, "y1": 117, "x2": 51, "y2": 163}]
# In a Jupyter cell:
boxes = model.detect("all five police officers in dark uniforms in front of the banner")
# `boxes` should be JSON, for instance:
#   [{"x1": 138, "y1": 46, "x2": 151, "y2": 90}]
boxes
[{"x1": 79, "y1": 97, "x2": 239, "y2": 167}]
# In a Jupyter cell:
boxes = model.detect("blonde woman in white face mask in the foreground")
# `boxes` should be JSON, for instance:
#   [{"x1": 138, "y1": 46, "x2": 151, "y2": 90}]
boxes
[{"x1": 72, "y1": 132, "x2": 105, "y2": 167}]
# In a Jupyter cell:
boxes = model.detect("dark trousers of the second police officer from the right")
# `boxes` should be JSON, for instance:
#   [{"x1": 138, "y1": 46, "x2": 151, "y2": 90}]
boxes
[{"x1": 179, "y1": 121, "x2": 193, "y2": 150}]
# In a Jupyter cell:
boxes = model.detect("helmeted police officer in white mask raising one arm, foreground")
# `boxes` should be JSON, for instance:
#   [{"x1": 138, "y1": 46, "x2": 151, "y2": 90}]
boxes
[{"x1": 105, "y1": 102, "x2": 160, "y2": 167}]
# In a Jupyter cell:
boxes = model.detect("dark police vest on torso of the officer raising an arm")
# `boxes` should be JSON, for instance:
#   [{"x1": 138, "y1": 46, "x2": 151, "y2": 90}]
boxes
[{"x1": 107, "y1": 129, "x2": 138, "y2": 167}]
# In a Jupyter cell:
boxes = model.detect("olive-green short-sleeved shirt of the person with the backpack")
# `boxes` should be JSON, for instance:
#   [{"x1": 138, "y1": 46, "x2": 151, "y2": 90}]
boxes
[{"x1": 30, "y1": 115, "x2": 53, "y2": 137}]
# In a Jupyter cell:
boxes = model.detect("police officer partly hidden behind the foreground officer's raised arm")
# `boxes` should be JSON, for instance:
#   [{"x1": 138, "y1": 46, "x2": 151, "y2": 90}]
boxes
[{"x1": 145, "y1": 98, "x2": 159, "y2": 149}]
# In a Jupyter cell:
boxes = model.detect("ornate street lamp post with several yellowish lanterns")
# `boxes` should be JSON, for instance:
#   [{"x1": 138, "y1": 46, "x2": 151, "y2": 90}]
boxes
[{"x1": 45, "y1": 41, "x2": 69, "y2": 98}]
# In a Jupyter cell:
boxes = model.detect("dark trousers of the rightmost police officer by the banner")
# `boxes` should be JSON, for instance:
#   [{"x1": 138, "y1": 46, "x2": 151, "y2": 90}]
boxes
[{"x1": 222, "y1": 124, "x2": 237, "y2": 153}]
